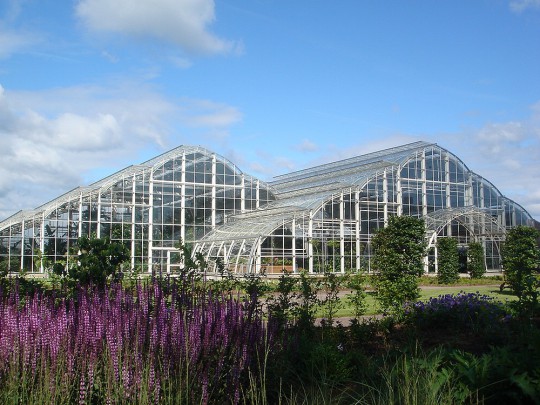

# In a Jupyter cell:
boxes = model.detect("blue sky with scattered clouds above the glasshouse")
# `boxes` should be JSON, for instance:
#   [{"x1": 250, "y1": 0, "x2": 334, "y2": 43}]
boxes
[{"x1": 0, "y1": 0, "x2": 540, "y2": 219}]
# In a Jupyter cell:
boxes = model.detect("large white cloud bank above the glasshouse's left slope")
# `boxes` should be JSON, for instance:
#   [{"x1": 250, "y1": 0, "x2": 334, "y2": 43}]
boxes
[{"x1": 0, "y1": 83, "x2": 241, "y2": 220}]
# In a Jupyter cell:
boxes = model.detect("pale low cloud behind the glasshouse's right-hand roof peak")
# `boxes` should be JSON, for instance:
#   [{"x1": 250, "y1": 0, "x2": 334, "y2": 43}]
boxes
[{"x1": 294, "y1": 123, "x2": 540, "y2": 221}]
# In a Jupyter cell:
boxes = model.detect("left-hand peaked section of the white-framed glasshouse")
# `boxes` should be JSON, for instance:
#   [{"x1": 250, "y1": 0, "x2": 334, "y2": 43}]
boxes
[{"x1": 0, "y1": 147, "x2": 275, "y2": 272}]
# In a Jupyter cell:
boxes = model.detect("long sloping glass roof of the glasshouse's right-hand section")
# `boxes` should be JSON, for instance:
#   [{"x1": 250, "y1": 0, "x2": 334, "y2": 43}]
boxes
[{"x1": 198, "y1": 141, "x2": 526, "y2": 242}]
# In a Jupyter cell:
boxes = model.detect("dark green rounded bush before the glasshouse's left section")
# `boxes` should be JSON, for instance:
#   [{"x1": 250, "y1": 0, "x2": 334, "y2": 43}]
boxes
[{"x1": 53, "y1": 236, "x2": 129, "y2": 287}]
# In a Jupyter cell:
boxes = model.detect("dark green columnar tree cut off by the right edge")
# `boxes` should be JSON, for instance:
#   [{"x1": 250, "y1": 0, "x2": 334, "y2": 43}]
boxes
[{"x1": 501, "y1": 226, "x2": 540, "y2": 315}]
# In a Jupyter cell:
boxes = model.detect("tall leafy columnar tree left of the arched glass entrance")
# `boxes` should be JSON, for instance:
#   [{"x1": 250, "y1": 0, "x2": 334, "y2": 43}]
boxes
[{"x1": 371, "y1": 216, "x2": 426, "y2": 313}]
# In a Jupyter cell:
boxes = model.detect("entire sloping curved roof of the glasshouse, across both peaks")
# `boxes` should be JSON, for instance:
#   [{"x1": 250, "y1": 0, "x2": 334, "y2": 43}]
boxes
[{"x1": 0, "y1": 141, "x2": 526, "y2": 240}]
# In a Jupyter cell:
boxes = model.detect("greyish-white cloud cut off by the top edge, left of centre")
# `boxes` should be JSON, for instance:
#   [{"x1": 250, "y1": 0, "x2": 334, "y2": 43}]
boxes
[{"x1": 76, "y1": 0, "x2": 239, "y2": 54}]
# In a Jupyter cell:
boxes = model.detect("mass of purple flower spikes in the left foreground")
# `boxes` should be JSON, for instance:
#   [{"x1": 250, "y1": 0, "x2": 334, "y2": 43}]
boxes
[{"x1": 0, "y1": 283, "x2": 284, "y2": 402}]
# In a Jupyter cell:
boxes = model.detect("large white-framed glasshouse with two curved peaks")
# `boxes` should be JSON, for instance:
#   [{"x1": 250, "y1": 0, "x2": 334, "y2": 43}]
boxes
[{"x1": 0, "y1": 142, "x2": 534, "y2": 274}]
